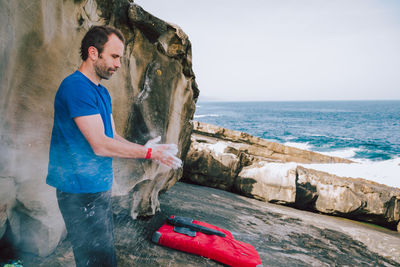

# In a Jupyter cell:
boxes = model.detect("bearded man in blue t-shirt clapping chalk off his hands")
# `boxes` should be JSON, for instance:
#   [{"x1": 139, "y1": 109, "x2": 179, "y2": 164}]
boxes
[{"x1": 47, "y1": 26, "x2": 181, "y2": 267}]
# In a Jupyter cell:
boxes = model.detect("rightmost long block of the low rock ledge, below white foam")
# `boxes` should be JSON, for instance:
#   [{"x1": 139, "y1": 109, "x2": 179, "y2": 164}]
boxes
[{"x1": 296, "y1": 166, "x2": 400, "y2": 229}]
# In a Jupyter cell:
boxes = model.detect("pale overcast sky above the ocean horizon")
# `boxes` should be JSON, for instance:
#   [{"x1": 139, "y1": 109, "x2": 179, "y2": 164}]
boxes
[{"x1": 135, "y1": 0, "x2": 400, "y2": 101}]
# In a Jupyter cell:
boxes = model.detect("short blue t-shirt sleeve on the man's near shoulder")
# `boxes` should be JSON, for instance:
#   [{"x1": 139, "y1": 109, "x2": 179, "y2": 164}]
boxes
[{"x1": 63, "y1": 79, "x2": 100, "y2": 118}]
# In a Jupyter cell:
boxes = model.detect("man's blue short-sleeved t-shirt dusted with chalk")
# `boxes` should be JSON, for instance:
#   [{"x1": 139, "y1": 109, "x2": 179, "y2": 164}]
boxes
[{"x1": 46, "y1": 71, "x2": 113, "y2": 193}]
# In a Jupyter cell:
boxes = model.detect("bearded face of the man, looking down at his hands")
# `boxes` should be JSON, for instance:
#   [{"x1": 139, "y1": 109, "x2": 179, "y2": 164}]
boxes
[{"x1": 94, "y1": 34, "x2": 124, "y2": 80}]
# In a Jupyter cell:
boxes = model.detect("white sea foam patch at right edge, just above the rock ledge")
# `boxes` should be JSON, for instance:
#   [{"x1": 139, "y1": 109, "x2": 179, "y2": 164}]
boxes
[{"x1": 301, "y1": 158, "x2": 400, "y2": 188}]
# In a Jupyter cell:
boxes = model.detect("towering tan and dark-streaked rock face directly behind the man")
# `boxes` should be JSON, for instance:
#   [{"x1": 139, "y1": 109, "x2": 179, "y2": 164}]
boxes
[{"x1": 0, "y1": 0, "x2": 198, "y2": 255}]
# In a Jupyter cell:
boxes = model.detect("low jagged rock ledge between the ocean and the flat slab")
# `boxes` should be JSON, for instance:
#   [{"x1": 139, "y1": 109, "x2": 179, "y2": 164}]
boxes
[{"x1": 184, "y1": 122, "x2": 400, "y2": 230}]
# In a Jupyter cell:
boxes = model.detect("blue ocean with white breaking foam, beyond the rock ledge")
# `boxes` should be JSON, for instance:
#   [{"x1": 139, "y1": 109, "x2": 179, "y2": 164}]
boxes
[{"x1": 194, "y1": 100, "x2": 400, "y2": 188}]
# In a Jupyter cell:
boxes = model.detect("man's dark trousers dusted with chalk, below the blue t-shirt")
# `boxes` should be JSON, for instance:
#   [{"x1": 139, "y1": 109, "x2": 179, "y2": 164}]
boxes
[{"x1": 57, "y1": 190, "x2": 117, "y2": 267}]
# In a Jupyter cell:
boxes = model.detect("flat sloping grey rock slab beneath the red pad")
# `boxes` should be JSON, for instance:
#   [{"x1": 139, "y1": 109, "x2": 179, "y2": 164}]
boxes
[{"x1": 19, "y1": 183, "x2": 400, "y2": 267}]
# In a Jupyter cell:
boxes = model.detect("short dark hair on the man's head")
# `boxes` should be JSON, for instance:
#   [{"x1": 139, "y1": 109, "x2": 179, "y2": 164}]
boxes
[{"x1": 81, "y1": 26, "x2": 125, "y2": 61}]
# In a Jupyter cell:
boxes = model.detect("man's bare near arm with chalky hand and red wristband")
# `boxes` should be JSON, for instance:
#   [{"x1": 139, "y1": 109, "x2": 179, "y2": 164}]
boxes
[{"x1": 74, "y1": 114, "x2": 179, "y2": 167}]
